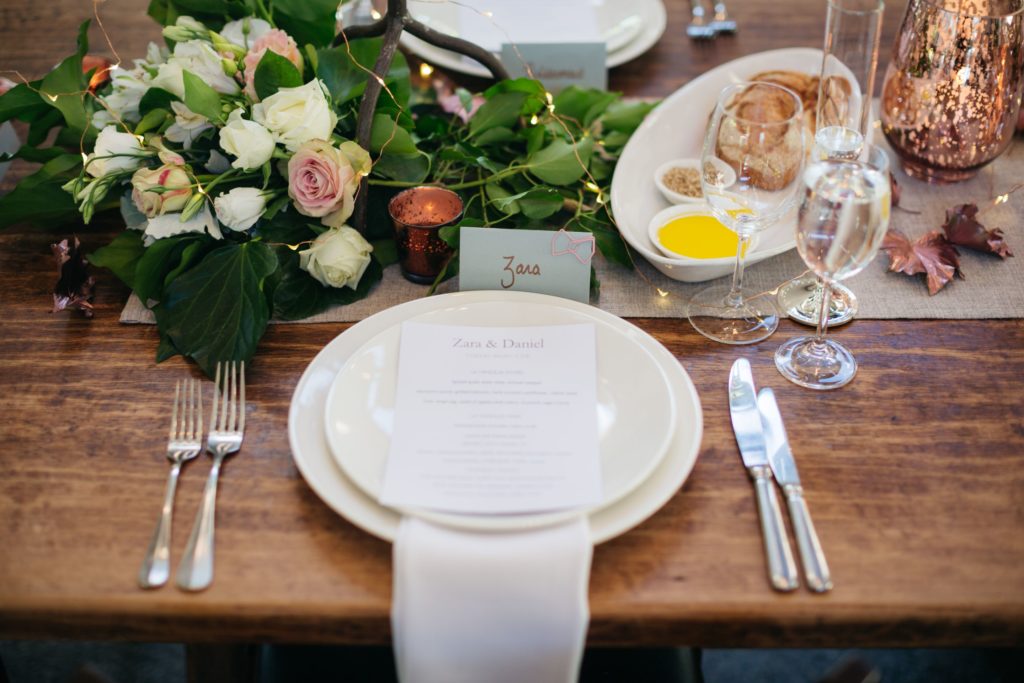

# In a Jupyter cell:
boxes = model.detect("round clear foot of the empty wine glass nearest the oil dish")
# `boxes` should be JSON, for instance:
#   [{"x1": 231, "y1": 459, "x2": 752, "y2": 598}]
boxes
[{"x1": 686, "y1": 285, "x2": 779, "y2": 344}]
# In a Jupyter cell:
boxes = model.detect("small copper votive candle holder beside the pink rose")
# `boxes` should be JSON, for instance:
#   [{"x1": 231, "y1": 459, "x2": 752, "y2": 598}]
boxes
[{"x1": 387, "y1": 185, "x2": 463, "y2": 285}]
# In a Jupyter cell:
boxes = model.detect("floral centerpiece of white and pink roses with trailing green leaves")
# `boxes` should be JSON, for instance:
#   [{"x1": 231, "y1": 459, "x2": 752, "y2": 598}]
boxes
[{"x1": 0, "y1": 0, "x2": 651, "y2": 371}]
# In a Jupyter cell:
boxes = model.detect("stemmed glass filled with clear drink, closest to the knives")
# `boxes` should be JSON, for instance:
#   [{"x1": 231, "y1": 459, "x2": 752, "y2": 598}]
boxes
[{"x1": 775, "y1": 147, "x2": 892, "y2": 389}]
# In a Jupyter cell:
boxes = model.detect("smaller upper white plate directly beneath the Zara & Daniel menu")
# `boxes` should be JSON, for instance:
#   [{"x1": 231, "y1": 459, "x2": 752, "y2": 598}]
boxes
[{"x1": 325, "y1": 298, "x2": 676, "y2": 530}]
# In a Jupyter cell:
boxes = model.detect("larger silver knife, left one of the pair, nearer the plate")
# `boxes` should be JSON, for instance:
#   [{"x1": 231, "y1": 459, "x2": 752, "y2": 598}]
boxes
[{"x1": 729, "y1": 358, "x2": 798, "y2": 591}]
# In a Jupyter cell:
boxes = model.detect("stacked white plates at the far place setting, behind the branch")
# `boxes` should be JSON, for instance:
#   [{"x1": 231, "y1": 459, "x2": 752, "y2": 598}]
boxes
[{"x1": 401, "y1": 0, "x2": 668, "y2": 78}]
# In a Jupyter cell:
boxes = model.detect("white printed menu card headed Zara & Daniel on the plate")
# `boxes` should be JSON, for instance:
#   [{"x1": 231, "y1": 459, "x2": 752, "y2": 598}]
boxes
[{"x1": 381, "y1": 322, "x2": 601, "y2": 514}]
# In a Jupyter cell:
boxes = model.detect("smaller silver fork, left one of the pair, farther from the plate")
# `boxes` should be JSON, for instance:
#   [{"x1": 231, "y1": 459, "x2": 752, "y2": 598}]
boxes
[{"x1": 138, "y1": 379, "x2": 203, "y2": 588}]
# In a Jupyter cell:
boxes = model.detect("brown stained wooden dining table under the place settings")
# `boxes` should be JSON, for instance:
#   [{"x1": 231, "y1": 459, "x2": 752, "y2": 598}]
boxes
[{"x1": 0, "y1": 0, "x2": 1024, "y2": 646}]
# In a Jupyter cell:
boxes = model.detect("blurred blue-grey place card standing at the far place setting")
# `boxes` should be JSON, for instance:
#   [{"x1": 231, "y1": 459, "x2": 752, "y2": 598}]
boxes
[{"x1": 501, "y1": 39, "x2": 608, "y2": 93}]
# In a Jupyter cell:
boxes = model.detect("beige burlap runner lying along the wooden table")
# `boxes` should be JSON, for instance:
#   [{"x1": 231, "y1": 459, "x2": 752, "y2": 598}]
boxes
[{"x1": 121, "y1": 136, "x2": 1024, "y2": 324}]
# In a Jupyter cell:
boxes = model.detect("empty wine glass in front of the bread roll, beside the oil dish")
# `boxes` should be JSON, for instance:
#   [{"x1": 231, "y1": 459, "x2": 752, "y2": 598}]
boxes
[{"x1": 687, "y1": 82, "x2": 805, "y2": 344}]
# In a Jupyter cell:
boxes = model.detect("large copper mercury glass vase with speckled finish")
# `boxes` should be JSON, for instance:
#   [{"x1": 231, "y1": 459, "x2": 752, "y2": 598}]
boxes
[{"x1": 881, "y1": 0, "x2": 1024, "y2": 182}]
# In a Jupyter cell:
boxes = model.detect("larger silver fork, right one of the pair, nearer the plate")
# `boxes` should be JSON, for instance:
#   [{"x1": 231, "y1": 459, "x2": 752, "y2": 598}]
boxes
[{"x1": 177, "y1": 360, "x2": 246, "y2": 591}]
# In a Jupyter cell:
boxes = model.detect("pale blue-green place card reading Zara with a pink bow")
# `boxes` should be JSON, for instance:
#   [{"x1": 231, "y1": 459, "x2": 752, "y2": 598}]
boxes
[{"x1": 459, "y1": 227, "x2": 595, "y2": 303}]
